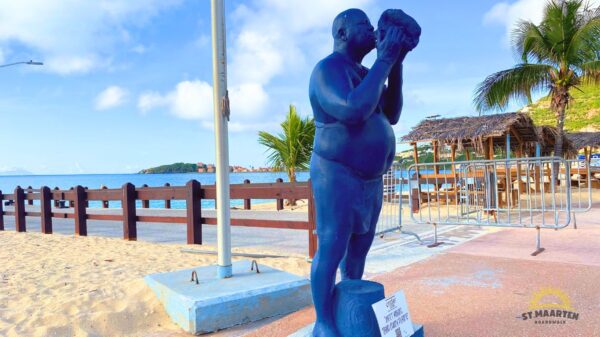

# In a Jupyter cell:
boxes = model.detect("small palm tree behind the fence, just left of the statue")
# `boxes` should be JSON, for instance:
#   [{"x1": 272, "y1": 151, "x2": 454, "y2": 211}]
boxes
[{"x1": 258, "y1": 104, "x2": 315, "y2": 206}]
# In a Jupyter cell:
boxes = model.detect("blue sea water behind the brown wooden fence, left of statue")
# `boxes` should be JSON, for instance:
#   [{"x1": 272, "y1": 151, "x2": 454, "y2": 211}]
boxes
[{"x1": 0, "y1": 172, "x2": 309, "y2": 208}]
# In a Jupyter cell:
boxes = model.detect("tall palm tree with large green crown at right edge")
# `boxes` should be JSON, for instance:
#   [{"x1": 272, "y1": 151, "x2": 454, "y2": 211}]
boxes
[{"x1": 474, "y1": 0, "x2": 600, "y2": 157}]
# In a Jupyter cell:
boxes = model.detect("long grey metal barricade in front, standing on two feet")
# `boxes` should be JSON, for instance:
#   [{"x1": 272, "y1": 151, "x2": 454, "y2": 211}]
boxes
[{"x1": 408, "y1": 157, "x2": 576, "y2": 254}]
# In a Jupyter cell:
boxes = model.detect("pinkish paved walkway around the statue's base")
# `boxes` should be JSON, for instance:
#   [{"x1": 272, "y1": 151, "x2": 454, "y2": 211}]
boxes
[{"x1": 246, "y1": 204, "x2": 600, "y2": 337}]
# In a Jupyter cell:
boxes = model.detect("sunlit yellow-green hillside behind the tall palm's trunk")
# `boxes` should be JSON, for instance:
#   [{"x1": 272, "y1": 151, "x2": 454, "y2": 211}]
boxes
[{"x1": 521, "y1": 85, "x2": 600, "y2": 132}]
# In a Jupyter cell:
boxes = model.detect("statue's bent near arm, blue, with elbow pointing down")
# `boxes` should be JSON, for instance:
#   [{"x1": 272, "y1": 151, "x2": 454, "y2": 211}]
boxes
[{"x1": 312, "y1": 59, "x2": 392, "y2": 124}]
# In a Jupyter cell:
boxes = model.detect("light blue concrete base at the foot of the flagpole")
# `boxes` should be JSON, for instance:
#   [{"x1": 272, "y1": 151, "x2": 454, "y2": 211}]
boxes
[{"x1": 144, "y1": 261, "x2": 312, "y2": 334}]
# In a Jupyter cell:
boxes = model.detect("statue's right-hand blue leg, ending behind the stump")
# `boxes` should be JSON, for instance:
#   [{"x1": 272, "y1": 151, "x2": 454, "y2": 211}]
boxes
[{"x1": 340, "y1": 180, "x2": 383, "y2": 280}]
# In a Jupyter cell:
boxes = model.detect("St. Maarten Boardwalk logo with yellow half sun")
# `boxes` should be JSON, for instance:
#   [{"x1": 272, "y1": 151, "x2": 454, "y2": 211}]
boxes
[{"x1": 518, "y1": 288, "x2": 579, "y2": 324}]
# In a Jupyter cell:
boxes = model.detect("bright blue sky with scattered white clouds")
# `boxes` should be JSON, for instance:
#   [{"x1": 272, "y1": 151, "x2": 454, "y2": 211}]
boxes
[{"x1": 0, "y1": 0, "x2": 600, "y2": 174}]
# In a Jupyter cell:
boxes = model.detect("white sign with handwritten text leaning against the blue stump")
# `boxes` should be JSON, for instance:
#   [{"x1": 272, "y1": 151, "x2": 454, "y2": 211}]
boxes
[{"x1": 373, "y1": 290, "x2": 415, "y2": 337}]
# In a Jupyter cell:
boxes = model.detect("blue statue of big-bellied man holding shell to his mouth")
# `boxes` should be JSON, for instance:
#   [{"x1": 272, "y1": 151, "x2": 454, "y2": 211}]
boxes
[{"x1": 309, "y1": 9, "x2": 421, "y2": 337}]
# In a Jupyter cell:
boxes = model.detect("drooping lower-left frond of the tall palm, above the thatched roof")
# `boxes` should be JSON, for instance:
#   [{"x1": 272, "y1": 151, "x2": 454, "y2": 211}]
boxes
[{"x1": 473, "y1": 64, "x2": 553, "y2": 113}]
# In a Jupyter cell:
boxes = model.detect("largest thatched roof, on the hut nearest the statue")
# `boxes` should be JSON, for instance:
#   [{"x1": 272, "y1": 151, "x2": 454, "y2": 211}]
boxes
[{"x1": 402, "y1": 112, "x2": 538, "y2": 149}]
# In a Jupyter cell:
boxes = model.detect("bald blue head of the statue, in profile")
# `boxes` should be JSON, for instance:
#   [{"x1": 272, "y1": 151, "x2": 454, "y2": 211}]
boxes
[{"x1": 332, "y1": 8, "x2": 376, "y2": 56}]
